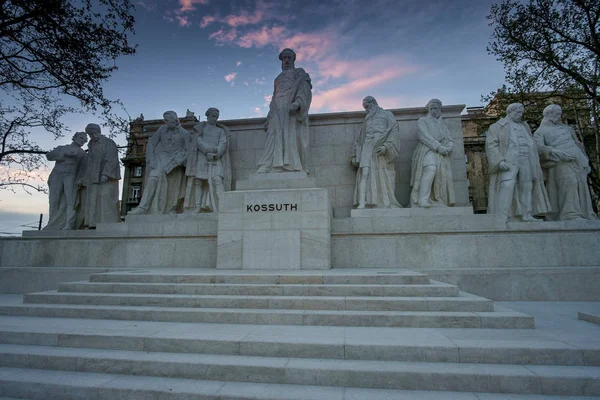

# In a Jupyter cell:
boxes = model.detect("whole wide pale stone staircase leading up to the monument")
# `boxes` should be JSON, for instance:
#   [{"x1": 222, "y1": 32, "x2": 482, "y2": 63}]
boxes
[{"x1": 0, "y1": 269, "x2": 600, "y2": 400}]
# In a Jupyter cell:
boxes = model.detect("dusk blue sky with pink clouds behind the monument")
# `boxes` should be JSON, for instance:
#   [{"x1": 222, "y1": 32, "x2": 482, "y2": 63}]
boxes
[{"x1": 0, "y1": 0, "x2": 504, "y2": 232}]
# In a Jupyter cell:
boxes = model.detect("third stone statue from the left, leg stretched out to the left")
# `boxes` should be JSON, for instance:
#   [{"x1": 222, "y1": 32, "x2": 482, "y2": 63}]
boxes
[{"x1": 129, "y1": 111, "x2": 190, "y2": 215}]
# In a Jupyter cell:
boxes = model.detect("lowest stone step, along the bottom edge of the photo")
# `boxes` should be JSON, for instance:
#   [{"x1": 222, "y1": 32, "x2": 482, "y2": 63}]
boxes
[{"x1": 0, "y1": 368, "x2": 600, "y2": 400}]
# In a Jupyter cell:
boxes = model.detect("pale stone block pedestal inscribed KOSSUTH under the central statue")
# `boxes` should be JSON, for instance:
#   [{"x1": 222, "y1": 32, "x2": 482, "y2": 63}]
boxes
[{"x1": 217, "y1": 173, "x2": 332, "y2": 270}]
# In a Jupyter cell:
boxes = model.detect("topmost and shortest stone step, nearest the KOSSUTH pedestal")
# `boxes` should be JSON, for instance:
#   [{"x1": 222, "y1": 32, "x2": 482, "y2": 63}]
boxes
[{"x1": 90, "y1": 269, "x2": 430, "y2": 285}]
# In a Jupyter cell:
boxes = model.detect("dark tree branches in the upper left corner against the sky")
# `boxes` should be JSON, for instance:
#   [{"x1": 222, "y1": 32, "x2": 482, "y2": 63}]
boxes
[{"x1": 0, "y1": 0, "x2": 135, "y2": 194}]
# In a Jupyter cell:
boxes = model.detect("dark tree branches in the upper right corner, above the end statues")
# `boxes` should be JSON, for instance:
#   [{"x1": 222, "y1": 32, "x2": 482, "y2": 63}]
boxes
[{"x1": 484, "y1": 0, "x2": 600, "y2": 194}]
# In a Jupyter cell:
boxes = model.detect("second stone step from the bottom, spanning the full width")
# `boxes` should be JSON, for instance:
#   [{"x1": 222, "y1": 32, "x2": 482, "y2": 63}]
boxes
[{"x1": 0, "y1": 345, "x2": 600, "y2": 396}]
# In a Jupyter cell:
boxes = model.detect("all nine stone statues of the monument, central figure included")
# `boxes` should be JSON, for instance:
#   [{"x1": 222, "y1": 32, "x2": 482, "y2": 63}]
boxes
[{"x1": 46, "y1": 49, "x2": 596, "y2": 229}]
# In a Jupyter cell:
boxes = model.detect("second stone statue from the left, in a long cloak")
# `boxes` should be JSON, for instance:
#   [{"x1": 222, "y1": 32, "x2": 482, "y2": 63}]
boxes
[{"x1": 84, "y1": 124, "x2": 121, "y2": 229}]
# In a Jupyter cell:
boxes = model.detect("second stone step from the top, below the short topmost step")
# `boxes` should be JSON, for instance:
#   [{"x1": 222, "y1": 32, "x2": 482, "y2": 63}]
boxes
[{"x1": 58, "y1": 281, "x2": 459, "y2": 297}]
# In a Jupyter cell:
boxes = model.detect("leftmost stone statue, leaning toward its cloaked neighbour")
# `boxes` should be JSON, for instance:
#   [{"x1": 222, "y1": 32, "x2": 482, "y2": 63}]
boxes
[{"x1": 44, "y1": 132, "x2": 87, "y2": 229}]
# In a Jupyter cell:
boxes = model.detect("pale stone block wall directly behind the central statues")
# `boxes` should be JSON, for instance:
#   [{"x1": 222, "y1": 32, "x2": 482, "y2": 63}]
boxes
[{"x1": 123, "y1": 105, "x2": 469, "y2": 217}]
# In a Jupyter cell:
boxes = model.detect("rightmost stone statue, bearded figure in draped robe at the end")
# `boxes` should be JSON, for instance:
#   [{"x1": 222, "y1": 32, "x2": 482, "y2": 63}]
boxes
[{"x1": 533, "y1": 104, "x2": 598, "y2": 220}]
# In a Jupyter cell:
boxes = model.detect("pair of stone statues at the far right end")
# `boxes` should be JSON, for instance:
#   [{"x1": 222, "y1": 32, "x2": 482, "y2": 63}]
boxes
[{"x1": 486, "y1": 103, "x2": 597, "y2": 222}]
